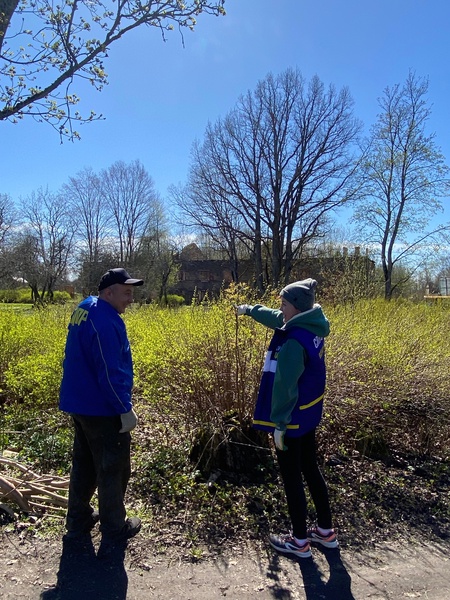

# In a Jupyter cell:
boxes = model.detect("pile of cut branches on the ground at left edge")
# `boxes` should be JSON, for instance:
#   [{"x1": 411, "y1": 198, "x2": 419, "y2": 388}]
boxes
[{"x1": 0, "y1": 457, "x2": 69, "y2": 514}]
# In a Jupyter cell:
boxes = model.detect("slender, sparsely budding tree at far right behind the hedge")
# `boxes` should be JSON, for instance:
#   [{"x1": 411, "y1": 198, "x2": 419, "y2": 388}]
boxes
[{"x1": 354, "y1": 72, "x2": 450, "y2": 300}]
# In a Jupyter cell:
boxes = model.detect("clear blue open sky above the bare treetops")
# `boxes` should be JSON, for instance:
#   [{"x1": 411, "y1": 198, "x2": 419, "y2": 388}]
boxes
[{"x1": 0, "y1": 0, "x2": 450, "y2": 229}]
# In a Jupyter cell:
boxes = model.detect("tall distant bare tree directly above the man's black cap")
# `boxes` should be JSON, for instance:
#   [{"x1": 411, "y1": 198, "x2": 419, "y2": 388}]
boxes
[{"x1": 99, "y1": 160, "x2": 159, "y2": 265}]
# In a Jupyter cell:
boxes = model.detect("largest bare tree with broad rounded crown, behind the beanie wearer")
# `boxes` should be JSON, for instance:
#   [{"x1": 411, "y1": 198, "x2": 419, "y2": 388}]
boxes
[{"x1": 177, "y1": 69, "x2": 360, "y2": 290}]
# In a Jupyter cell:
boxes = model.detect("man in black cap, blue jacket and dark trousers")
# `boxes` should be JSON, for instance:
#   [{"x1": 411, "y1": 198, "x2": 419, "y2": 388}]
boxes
[{"x1": 59, "y1": 268, "x2": 144, "y2": 543}]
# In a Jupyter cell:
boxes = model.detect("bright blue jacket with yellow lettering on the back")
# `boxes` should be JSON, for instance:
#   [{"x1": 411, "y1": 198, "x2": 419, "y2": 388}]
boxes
[{"x1": 59, "y1": 296, "x2": 133, "y2": 416}]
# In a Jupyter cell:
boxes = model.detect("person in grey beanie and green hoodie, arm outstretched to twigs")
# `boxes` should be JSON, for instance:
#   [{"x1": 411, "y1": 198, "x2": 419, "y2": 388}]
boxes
[{"x1": 236, "y1": 278, "x2": 338, "y2": 558}]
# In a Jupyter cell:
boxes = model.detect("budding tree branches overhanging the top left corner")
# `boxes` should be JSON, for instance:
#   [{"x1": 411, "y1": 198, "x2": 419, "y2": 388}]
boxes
[{"x1": 0, "y1": 0, "x2": 225, "y2": 139}]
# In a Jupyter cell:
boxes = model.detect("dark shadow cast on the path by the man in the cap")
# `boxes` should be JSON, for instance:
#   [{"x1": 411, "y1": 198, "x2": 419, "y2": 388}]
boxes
[{"x1": 40, "y1": 536, "x2": 128, "y2": 600}]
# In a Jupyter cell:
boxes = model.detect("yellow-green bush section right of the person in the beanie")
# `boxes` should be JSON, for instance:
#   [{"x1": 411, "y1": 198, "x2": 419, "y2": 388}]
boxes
[{"x1": 325, "y1": 299, "x2": 450, "y2": 455}]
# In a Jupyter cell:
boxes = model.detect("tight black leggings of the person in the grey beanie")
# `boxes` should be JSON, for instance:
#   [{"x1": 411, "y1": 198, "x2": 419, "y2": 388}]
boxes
[{"x1": 277, "y1": 429, "x2": 332, "y2": 540}]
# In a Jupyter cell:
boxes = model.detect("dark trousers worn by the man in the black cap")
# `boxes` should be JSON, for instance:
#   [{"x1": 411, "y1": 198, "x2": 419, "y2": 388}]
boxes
[{"x1": 66, "y1": 415, "x2": 131, "y2": 535}]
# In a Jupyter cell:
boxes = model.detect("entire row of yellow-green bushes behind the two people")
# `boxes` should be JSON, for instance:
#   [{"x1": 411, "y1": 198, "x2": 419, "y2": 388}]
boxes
[{"x1": 0, "y1": 288, "x2": 450, "y2": 464}]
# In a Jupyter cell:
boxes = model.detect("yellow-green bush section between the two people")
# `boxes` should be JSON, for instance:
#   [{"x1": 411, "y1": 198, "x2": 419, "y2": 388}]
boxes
[{"x1": 126, "y1": 299, "x2": 266, "y2": 426}]
